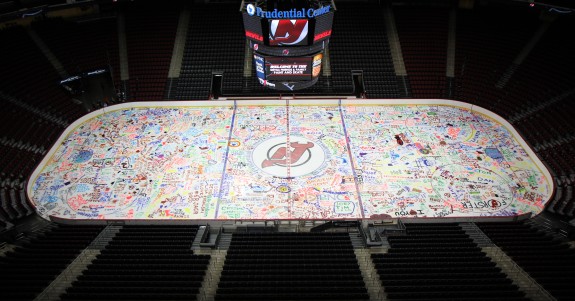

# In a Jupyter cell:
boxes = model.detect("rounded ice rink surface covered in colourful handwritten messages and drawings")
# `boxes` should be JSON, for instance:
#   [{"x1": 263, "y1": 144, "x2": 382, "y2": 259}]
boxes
[{"x1": 28, "y1": 99, "x2": 553, "y2": 220}]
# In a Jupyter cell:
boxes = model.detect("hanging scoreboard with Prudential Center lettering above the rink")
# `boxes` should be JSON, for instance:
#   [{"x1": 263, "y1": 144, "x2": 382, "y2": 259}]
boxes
[{"x1": 242, "y1": 0, "x2": 334, "y2": 91}]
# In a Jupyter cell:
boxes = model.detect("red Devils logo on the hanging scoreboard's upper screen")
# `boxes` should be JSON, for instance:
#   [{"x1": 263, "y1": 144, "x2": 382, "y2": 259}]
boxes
[{"x1": 269, "y1": 19, "x2": 308, "y2": 46}]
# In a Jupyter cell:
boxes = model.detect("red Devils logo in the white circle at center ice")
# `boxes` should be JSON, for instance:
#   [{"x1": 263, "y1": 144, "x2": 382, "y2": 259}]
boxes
[{"x1": 262, "y1": 142, "x2": 314, "y2": 168}]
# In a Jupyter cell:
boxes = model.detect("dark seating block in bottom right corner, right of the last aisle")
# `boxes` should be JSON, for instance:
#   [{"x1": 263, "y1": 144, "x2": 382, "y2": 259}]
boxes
[{"x1": 477, "y1": 222, "x2": 575, "y2": 300}]
